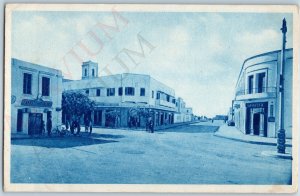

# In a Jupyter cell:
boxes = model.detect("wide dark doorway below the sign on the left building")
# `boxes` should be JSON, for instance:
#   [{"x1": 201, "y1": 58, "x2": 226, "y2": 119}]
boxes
[{"x1": 28, "y1": 113, "x2": 43, "y2": 135}]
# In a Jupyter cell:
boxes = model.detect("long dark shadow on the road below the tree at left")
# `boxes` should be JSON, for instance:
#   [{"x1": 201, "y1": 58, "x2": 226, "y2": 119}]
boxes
[{"x1": 11, "y1": 136, "x2": 118, "y2": 148}]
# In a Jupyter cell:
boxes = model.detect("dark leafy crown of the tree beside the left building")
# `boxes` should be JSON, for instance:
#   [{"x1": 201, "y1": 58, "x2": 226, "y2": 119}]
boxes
[{"x1": 62, "y1": 91, "x2": 95, "y2": 125}]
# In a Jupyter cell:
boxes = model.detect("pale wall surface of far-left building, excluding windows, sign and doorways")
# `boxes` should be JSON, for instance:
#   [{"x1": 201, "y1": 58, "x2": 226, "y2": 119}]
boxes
[{"x1": 11, "y1": 59, "x2": 62, "y2": 133}]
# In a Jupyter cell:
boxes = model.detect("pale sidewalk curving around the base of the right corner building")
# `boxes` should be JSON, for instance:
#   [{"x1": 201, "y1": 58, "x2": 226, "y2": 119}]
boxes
[{"x1": 214, "y1": 124, "x2": 292, "y2": 147}]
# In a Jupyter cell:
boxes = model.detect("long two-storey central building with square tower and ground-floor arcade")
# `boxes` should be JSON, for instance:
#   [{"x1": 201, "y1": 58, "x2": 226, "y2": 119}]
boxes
[{"x1": 63, "y1": 61, "x2": 188, "y2": 127}]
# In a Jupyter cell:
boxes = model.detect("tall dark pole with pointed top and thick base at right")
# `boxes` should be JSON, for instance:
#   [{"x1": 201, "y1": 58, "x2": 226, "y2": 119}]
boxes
[{"x1": 277, "y1": 18, "x2": 287, "y2": 154}]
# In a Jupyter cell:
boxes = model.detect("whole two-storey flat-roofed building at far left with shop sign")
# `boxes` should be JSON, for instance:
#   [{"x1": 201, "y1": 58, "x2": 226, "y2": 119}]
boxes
[{"x1": 11, "y1": 58, "x2": 62, "y2": 135}]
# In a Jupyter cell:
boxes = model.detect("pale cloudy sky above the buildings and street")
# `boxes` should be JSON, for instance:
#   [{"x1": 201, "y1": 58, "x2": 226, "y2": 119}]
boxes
[{"x1": 12, "y1": 11, "x2": 292, "y2": 117}]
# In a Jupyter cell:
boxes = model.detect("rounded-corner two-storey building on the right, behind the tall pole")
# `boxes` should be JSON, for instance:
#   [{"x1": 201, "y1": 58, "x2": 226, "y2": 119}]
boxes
[{"x1": 233, "y1": 49, "x2": 293, "y2": 138}]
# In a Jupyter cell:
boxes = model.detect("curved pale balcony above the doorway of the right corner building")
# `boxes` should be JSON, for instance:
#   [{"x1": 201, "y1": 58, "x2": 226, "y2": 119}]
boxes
[{"x1": 235, "y1": 87, "x2": 277, "y2": 100}]
